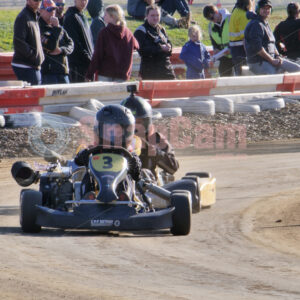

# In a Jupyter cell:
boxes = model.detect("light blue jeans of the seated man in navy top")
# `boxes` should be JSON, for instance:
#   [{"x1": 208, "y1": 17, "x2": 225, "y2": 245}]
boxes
[{"x1": 248, "y1": 58, "x2": 300, "y2": 75}]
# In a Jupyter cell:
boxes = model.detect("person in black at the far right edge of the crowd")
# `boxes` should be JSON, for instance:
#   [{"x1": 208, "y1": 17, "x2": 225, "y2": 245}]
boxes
[{"x1": 274, "y1": 2, "x2": 300, "y2": 61}]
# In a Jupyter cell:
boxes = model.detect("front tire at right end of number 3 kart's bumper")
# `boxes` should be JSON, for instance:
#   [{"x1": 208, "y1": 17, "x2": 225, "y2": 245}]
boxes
[{"x1": 171, "y1": 191, "x2": 192, "y2": 235}]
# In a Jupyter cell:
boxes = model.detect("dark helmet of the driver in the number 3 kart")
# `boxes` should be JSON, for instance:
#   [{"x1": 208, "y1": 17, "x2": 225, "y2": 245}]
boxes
[{"x1": 94, "y1": 104, "x2": 135, "y2": 149}]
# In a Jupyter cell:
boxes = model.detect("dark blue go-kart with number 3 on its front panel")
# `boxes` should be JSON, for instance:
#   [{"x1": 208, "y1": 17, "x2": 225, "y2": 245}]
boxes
[{"x1": 11, "y1": 146, "x2": 192, "y2": 235}]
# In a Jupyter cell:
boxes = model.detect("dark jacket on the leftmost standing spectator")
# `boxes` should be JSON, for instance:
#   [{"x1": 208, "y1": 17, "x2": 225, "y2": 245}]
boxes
[{"x1": 12, "y1": 6, "x2": 44, "y2": 69}]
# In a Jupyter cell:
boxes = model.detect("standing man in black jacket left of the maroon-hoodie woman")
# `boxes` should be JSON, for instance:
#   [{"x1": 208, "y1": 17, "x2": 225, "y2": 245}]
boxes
[{"x1": 64, "y1": 0, "x2": 94, "y2": 82}]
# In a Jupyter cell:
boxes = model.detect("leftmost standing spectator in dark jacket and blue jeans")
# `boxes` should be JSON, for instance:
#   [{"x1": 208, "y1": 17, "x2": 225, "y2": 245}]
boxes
[{"x1": 12, "y1": 0, "x2": 44, "y2": 85}]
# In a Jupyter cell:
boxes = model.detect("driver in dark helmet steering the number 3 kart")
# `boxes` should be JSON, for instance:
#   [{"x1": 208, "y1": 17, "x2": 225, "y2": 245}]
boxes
[{"x1": 74, "y1": 104, "x2": 141, "y2": 195}]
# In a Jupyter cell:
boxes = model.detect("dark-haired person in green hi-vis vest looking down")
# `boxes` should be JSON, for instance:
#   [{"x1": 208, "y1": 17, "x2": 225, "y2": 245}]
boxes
[{"x1": 203, "y1": 5, "x2": 233, "y2": 76}]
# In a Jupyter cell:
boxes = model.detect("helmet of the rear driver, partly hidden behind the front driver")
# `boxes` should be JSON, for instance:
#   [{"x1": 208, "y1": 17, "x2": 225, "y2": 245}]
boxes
[{"x1": 121, "y1": 92, "x2": 152, "y2": 134}]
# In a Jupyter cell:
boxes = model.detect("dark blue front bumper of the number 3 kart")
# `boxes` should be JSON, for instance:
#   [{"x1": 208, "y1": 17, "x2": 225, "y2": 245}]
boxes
[{"x1": 36, "y1": 203, "x2": 174, "y2": 231}]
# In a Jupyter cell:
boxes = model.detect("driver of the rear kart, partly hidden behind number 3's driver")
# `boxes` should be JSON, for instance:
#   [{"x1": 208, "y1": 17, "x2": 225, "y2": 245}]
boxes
[{"x1": 121, "y1": 91, "x2": 179, "y2": 179}]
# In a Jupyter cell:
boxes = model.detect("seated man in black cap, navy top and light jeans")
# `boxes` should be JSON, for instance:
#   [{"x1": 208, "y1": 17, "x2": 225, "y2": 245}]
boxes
[{"x1": 245, "y1": 0, "x2": 300, "y2": 75}]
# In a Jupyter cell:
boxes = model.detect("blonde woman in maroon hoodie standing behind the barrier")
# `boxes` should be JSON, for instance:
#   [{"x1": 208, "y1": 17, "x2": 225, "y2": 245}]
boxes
[{"x1": 86, "y1": 5, "x2": 139, "y2": 82}]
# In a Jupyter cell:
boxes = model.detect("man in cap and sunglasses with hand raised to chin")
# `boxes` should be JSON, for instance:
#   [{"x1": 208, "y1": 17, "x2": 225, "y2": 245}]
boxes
[{"x1": 39, "y1": 0, "x2": 74, "y2": 84}]
